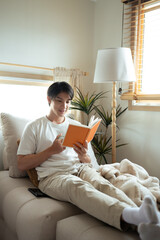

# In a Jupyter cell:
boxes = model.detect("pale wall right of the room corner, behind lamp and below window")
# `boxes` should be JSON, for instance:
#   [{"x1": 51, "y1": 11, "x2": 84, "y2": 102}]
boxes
[{"x1": 94, "y1": 0, "x2": 160, "y2": 178}]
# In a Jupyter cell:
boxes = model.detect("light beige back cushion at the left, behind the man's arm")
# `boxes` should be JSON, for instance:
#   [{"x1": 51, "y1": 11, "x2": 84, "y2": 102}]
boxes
[{"x1": 0, "y1": 113, "x2": 29, "y2": 177}]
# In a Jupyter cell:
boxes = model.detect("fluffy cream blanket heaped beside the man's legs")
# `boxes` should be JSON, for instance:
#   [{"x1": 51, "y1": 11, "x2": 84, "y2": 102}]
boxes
[{"x1": 99, "y1": 159, "x2": 160, "y2": 206}]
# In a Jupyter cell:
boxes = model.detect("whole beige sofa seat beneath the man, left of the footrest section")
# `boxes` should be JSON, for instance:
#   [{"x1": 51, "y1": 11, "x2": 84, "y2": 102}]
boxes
[{"x1": 0, "y1": 171, "x2": 82, "y2": 240}]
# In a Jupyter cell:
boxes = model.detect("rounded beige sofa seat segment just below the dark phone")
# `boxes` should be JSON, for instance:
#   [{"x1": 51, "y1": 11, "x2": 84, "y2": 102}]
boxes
[{"x1": 17, "y1": 195, "x2": 82, "y2": 240}]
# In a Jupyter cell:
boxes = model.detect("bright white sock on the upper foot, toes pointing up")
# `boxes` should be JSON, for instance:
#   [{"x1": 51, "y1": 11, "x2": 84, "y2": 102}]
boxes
[{"x1": 122, "y1": 196, "x2": 160, "y2": 226}]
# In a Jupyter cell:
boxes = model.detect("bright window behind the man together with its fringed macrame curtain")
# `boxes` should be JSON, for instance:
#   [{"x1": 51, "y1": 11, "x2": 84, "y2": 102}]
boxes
[{"x1": 0, "y1": 62, "x2": 88, "y2": 121}]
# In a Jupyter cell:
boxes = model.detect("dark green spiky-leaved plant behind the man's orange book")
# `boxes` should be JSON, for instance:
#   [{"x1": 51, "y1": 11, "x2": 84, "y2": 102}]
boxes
[{"x1": 70, "y1": 88, "x2": 127, "y2": 164}]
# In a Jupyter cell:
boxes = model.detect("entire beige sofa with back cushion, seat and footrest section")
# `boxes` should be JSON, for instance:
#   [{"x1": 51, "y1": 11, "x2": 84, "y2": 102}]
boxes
[{"x1": 0, "y1": 113, "x2": 139, "y2": 240}]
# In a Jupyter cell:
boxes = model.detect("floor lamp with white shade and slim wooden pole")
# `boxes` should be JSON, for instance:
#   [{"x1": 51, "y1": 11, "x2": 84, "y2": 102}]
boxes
[{"x1": 94, "y1": 47, "x2": 136, "y2": 163}]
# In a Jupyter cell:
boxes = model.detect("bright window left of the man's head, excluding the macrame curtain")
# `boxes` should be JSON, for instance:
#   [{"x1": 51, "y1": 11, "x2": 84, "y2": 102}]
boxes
[{"x1": 0, "y1": 63, "x2": 53, "y2": 119}]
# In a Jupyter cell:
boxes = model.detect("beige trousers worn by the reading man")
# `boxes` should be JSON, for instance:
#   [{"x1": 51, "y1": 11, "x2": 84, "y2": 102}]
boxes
[{"x1": 39, "y1": 164, "x2": 136, "y2": 230}]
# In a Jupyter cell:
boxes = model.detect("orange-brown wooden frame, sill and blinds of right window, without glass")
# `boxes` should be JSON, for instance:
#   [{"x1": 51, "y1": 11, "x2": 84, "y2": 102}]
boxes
[{"x1": 121, "y1": 0, "x2": 160, "y2": 111}]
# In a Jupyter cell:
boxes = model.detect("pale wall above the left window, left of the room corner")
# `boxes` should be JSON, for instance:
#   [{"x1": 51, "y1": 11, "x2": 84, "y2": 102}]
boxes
[{"x1": 0, "y1": 0, "x2": 94, "y2": 71}]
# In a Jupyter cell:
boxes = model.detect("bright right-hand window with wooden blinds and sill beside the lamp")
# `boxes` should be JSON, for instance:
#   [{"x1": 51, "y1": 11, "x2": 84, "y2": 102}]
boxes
[{"x1": 121, "y1": 0, "x2": 160, "y2": 110}]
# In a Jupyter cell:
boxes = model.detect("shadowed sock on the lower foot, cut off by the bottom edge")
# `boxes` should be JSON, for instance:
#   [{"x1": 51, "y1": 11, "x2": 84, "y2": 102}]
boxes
[{"x1": 138, "y1": 223, "x2": 160, "y2": 240}]
